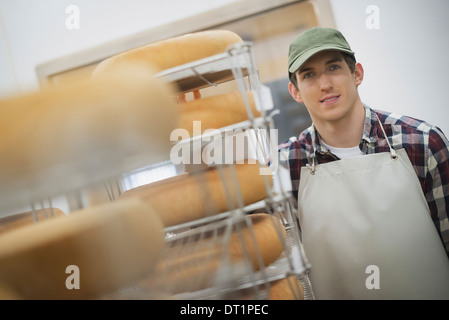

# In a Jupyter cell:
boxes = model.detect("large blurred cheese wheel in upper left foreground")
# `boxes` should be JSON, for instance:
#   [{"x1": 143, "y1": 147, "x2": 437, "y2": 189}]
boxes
[{"x1": 0, "y1": 64, "x2": 177, "y2": 209}]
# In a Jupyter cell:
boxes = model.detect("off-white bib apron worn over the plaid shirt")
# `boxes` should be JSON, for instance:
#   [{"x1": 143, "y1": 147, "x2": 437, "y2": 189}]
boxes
[{"x1": 298, "y1": 118, "x2": 449, "y2": 299}]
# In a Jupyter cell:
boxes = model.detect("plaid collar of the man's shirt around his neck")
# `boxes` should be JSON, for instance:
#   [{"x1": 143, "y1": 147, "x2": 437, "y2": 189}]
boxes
[{"x1": 310, "y1": 104, "x2": 378, "y2": 158}]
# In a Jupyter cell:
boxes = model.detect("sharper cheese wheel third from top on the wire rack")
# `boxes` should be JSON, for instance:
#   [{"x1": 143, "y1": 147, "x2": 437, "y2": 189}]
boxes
[{"x1": 120, "y1": 161, "x2": 272, "y2": 227}]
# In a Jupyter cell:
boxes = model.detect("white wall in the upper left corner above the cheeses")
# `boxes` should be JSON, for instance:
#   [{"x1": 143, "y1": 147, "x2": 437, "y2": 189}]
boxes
[{"x1": 0, "y1": 0, "x2": 237, "y2": 96}]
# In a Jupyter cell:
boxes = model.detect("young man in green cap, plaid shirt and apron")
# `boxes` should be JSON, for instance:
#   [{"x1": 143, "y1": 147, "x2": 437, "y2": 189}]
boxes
[{"x1": 280, "y1": 28, "x2": 449, "y2": 299}]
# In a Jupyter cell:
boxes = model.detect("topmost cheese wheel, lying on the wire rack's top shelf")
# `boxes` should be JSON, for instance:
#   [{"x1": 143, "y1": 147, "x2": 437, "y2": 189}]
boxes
[{"x1": 94, "y1": 30, "x2": 243, "y2": 76}]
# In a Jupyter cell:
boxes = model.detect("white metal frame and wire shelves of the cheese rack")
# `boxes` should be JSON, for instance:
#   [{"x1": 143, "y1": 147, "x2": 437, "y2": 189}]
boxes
[{"x1": 0, "y1": 42, "x2": 314, "y2": 299}]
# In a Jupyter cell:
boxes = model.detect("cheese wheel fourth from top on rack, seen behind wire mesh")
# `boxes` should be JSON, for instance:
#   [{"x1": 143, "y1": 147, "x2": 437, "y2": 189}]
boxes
[{"x1": 141, "y1": 213, "x2": 286, "y2": 294}]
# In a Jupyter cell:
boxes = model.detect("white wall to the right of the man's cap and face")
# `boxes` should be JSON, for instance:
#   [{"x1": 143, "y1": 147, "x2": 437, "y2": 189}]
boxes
[{"x1": 331, "y1": 0, "x2": 449, "y2": 136}]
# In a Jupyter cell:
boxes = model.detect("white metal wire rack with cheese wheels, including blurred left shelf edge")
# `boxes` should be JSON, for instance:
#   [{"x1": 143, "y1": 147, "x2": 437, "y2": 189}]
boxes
[{"x1": 3, "y1": 42, "x2": 314, "y2": 299}]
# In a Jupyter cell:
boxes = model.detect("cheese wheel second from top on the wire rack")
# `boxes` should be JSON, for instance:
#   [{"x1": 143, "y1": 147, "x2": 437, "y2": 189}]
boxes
[{"x1": 178, "y1": 91, "x2": 260, "y2": 136}]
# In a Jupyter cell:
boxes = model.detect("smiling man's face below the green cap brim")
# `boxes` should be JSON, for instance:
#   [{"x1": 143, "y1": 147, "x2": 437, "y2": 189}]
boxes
[{"x1": 289, "y1": 51, "x2": 363, "y2": 123}]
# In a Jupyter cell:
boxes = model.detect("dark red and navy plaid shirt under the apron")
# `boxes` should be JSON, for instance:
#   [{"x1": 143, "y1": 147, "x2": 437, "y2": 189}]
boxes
[{"x1": 279, "y1": 105, "x2": 449, "y2": 255}]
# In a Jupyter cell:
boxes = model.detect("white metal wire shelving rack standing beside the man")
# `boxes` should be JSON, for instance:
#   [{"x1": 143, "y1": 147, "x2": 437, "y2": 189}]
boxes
[{"x1": 104, "y1": 42, "x2": 314, "y2": 299}]
